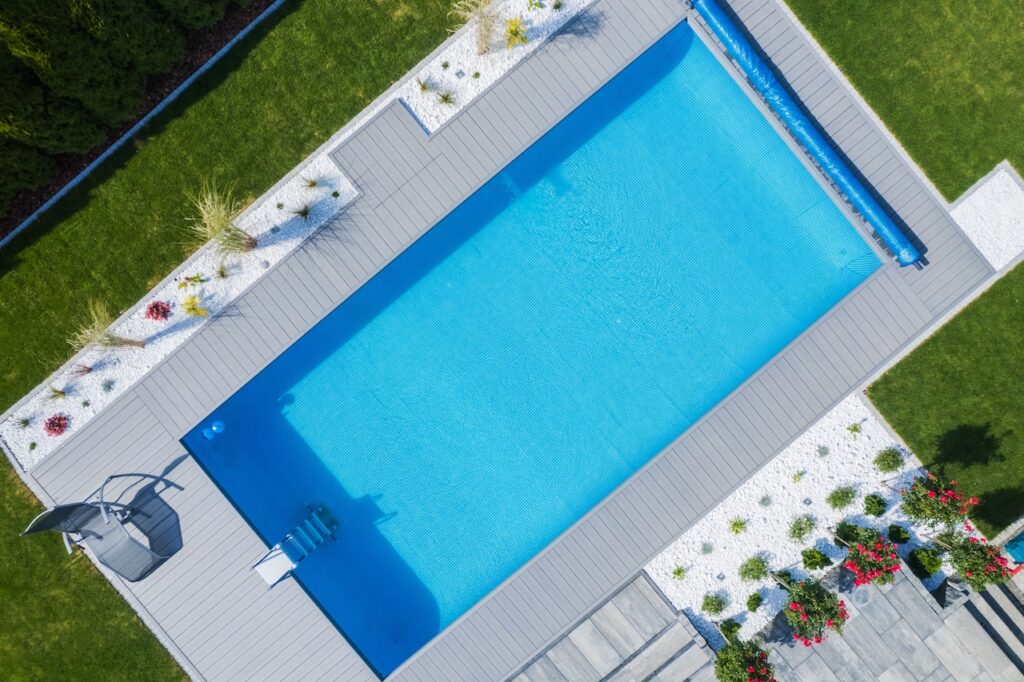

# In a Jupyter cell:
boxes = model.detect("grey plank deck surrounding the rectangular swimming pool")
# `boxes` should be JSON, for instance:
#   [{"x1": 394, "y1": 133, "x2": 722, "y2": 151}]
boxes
[{"x1": 12, "y1": 0, "x2": 992, "y2": 682}]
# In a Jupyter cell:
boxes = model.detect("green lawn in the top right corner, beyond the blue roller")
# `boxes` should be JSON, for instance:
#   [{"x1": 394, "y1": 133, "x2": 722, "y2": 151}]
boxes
[{"x1": 786, "y1": 0, "x2": 1024, "y2": 200}]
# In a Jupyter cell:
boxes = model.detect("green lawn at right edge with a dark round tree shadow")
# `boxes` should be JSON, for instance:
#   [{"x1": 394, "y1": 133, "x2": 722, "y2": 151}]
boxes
[{"x1": 868, "y1": 265, "x2": 1024, "y2": 538}]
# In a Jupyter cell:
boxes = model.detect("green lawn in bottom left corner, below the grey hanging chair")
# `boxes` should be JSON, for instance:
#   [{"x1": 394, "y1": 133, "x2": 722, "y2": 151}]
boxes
[{"x1": 0, "y1": 467, "x2": 187, "y2": 681}]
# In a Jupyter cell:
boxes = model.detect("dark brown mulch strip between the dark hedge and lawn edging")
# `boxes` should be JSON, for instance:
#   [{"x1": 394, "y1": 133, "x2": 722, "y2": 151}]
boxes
[{"x1": 0, "y1": 0, "x2": 274, "y2": 238}]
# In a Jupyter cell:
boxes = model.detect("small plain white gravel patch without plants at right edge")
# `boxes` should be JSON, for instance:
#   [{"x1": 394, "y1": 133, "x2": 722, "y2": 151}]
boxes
[{"x1": 949, "y1": 162, "x2": 1024, "y2": 270}]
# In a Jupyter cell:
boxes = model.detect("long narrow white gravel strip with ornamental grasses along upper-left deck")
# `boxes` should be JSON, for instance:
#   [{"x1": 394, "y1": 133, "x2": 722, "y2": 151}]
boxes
[{"x1": 0, "y1": 0, "x2": 592, "y2": 470}]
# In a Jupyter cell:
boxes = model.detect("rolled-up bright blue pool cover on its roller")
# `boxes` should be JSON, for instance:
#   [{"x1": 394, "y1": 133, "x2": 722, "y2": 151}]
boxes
[{"x1": 693, "y1": 0, "x2": 921, "y2": 265}]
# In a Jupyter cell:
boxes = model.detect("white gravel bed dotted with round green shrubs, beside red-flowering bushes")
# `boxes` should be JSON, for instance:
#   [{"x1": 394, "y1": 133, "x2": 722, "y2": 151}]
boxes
[{"x1": 646, "y1": 394, "x2": 944, "y2": 648}]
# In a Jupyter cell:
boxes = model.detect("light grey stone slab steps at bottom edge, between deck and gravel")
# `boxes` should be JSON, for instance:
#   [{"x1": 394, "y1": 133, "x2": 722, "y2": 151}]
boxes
[{"x1": 512, "y1": 573, "x2": 714, "y2": 682}]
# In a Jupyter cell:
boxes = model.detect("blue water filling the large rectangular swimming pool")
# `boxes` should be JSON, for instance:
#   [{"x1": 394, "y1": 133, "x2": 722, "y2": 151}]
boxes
[{"x1": 185, "y1": 24, "x2": 880, "y2": 674}]
